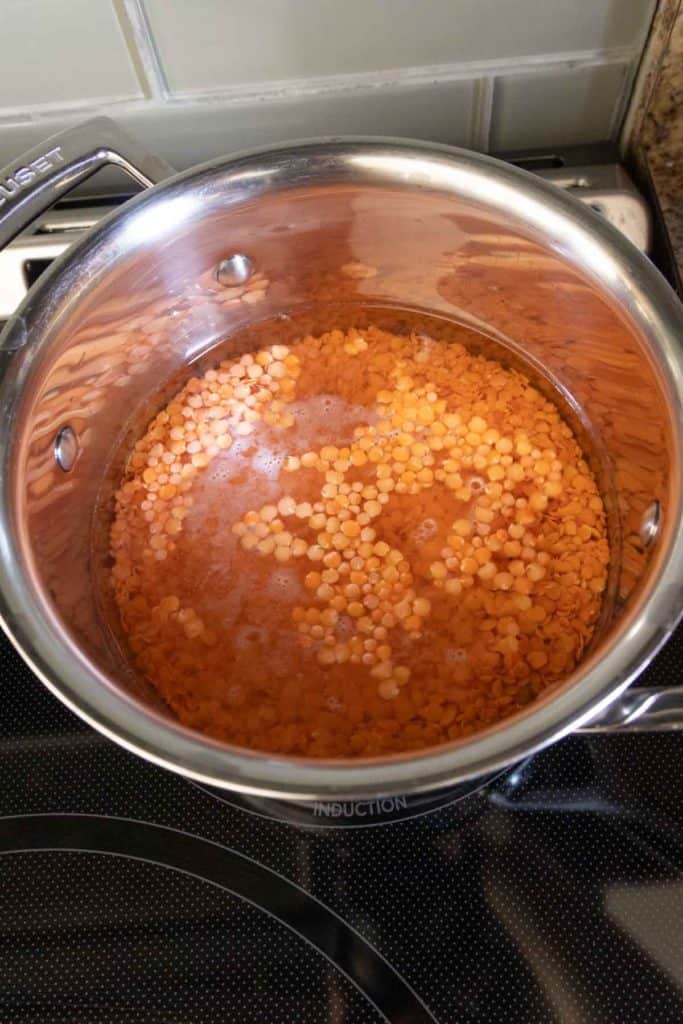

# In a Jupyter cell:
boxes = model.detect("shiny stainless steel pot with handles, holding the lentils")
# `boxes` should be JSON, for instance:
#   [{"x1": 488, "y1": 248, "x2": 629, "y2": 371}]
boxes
[{"x1": 0, "y1": 119, "x2": 683, "y2": 800}]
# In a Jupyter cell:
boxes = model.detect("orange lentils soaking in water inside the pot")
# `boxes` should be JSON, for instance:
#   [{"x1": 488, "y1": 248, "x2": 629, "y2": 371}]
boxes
[{"x1": 111, "y1": 317, "x2": 609, "y2": 758}]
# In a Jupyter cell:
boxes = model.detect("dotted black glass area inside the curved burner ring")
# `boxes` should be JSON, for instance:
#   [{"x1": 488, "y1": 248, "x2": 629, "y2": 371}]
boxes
[{"x1": 0, "y1": 852, "x2": 383, "y2": 1024}]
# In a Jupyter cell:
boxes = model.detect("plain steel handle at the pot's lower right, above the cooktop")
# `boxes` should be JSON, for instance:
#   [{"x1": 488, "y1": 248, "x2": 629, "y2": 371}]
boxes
[{"x1": 577, "y1": 686, "x2": 683, "y2": 733}]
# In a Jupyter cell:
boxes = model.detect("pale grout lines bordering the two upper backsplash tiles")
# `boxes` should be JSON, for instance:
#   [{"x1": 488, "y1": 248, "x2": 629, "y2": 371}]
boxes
[{"x1": 0, "y1": 44, "x2": 639, "y2": 125}]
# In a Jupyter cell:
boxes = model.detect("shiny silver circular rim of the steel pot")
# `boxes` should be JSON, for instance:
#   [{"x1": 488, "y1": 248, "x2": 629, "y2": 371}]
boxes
[{"x1": 0, "y1": 136, "x2": 683, "y2": 800}]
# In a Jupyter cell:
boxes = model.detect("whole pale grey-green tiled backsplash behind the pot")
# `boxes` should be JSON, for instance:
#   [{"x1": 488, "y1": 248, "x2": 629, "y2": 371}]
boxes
[{"x1": 0, "y1": 0, "x2": 655, "y2": 168}]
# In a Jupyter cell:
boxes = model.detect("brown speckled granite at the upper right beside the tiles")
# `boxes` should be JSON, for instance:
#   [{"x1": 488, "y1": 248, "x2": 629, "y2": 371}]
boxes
[{"x1": 630, "y1": 0, "x2": 683, "y2": 276}]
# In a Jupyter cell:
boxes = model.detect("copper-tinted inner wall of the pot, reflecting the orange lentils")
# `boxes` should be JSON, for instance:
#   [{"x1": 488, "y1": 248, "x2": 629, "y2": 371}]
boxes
[{"x1": 17, "y1": 178, "x2": 673, "y2": 720}]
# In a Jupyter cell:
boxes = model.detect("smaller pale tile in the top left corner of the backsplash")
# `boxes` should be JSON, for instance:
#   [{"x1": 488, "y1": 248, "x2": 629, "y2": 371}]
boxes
[{"x1": 0, "y1": 0, "x2": 142, "y2": 111}]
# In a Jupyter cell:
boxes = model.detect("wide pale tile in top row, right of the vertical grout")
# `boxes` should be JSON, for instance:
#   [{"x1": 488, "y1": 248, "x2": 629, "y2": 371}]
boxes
[{"x1": 144, "y1": 0, "x2": 649, "y2": 94}]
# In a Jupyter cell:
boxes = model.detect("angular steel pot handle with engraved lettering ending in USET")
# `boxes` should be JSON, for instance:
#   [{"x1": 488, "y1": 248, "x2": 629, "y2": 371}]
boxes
[{"x1": 0, "y1": 118, "x2": 176, "y2": 249}]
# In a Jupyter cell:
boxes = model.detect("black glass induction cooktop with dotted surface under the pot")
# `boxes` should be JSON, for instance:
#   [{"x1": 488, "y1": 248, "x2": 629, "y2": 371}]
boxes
[{"x1": 0, "y1": 630, "x2": 683, "y2": 1024}]
